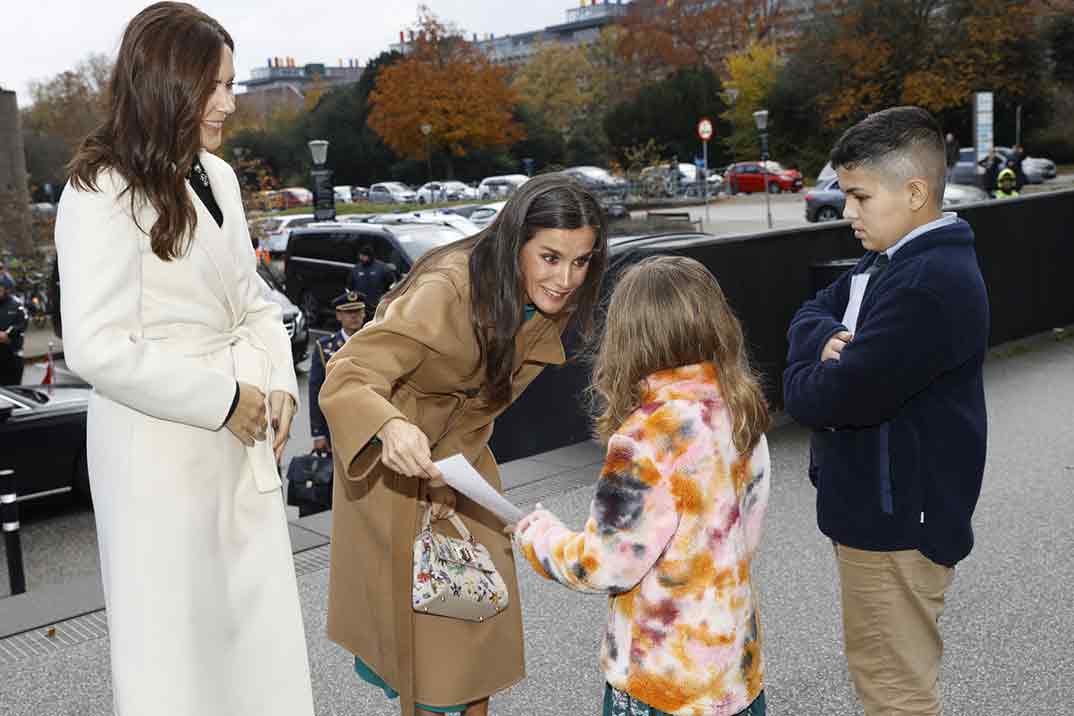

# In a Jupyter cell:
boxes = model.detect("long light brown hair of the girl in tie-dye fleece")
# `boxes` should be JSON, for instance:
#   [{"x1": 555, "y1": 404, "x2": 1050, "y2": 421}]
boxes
[{"x1": 590, "y1": 257, "x2": 769, "y2": 454}]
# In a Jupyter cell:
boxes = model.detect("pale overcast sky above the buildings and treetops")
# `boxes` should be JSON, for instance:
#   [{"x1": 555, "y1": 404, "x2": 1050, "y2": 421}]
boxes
[{"x1": 0, "y1": 0, "x2": 579, "y2": 106}]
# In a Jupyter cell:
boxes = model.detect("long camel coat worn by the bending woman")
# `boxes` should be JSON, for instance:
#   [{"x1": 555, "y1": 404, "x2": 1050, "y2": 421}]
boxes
[{"x1": 320, "y1": 251, "x2": 565, "y2": 714}]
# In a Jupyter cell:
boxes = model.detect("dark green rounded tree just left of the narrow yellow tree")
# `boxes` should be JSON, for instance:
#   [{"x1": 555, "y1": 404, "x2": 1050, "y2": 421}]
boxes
[{"x1": 605, "y1": 68, "x2": 728, "y2": 165}]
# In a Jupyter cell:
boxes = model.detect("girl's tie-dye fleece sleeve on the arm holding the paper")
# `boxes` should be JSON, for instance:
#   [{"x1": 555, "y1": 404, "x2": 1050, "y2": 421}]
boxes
[{"x1": 518, "y1": 435, "x2": 679, "y2": 593}]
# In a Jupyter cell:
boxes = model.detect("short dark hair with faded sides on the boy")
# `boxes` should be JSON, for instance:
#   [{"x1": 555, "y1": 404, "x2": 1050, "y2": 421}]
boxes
[{"x1": 829, "y1": 107, "x2": 947, "y2": 206}]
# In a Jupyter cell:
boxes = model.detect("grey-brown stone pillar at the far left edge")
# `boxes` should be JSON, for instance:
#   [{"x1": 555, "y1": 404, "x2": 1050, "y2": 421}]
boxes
[{"x1": 0, "y1": 89, "x2": 33, "y2": 255}]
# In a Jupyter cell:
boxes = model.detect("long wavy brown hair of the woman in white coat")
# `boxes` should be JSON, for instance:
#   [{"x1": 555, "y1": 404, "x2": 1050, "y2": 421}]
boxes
[{"x1": 68, "y1": 2, "x2": 235, "y2": 261}]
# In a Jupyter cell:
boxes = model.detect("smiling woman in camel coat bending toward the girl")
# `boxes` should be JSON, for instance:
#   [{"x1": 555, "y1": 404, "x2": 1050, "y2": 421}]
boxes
[{"x1": 320, "y1": 175, "x2": 607, "y2": 716}]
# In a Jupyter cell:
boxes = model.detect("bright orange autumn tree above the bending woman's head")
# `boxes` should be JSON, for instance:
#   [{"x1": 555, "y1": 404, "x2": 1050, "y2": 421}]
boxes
[{"x1": 368, "y1": 6, "x2": 523, "y2": 176}]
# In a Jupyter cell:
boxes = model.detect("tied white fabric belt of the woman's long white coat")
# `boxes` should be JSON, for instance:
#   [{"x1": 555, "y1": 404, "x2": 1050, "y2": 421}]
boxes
[{"x1": 143, "y1": 321, "x2": 282, "y2": 493}]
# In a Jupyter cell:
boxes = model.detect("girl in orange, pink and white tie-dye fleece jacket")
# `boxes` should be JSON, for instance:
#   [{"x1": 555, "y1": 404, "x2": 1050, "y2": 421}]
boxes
[{"x1": 516, "y1": 257, "x2": 769, "y2": 716}]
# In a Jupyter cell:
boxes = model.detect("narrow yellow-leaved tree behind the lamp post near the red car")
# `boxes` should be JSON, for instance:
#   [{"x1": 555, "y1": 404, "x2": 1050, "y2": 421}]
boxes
[{"x1": 723, "y1": 42, "x2": 783, "y2": 158}]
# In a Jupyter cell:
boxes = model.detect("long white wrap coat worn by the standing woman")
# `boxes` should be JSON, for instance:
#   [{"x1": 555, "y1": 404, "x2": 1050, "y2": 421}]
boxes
[{"x1": 56, "y1": 151, "x2": 314, "y2": 716}]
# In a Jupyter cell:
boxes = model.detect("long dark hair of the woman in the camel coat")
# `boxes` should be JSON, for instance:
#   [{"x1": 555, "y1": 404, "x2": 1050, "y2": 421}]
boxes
[{"x1": 384, "y1": 174, "x2": 608, "y2": 406}]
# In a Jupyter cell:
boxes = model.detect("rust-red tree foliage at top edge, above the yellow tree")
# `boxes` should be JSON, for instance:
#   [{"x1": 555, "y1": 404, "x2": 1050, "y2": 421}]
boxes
[{"x1": 620, "y1": 0, "x2": 784, "y2": 76}]
